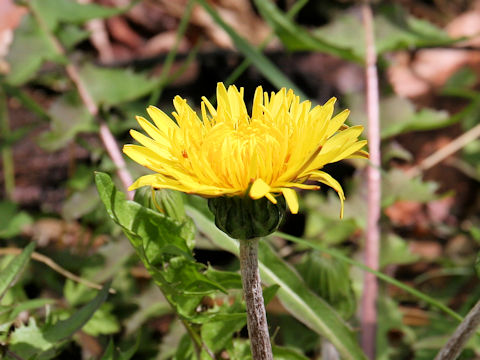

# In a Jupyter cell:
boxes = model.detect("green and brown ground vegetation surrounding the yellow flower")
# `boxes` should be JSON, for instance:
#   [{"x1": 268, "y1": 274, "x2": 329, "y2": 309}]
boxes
[{"x1": 0, "y1": 0, "x2": 480, "y2": 359}]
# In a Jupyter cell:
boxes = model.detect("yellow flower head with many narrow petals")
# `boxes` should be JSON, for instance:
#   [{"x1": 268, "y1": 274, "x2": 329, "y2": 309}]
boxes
[{"x1": 123, "y1": 83, "x2": 368, "y2": 216}]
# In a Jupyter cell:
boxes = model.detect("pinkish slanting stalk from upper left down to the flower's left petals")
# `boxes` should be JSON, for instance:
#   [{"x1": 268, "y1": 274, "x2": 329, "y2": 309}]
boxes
[{"x1": 30, "y1": 0, "x2": 134, "y2": 199}]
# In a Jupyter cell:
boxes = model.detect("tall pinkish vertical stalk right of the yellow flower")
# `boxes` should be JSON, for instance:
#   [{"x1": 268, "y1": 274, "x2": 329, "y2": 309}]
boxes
[{"x1": 361, "y1": 2, "x2": 381, "y2": 359}]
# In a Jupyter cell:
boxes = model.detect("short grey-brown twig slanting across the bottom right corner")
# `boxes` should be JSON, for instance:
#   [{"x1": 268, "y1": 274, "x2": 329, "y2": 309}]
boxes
[{"x1": 435, "y1": 301, "x2": 480, "y2": 360}]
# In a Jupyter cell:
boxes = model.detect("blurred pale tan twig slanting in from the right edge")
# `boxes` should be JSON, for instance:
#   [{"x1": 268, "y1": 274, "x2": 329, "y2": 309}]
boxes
[{"x1": 407, "y1": 124, "x2": 480, "y2": 178}]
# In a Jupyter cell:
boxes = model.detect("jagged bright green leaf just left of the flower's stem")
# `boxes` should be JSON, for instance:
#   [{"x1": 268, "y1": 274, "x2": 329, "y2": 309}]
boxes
[{"x1": 95, "y1": 173, "x2": 232, "y2": 318}]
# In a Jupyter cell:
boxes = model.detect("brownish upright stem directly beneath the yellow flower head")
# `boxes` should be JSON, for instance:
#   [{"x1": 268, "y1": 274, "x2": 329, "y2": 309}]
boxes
[{"x1": 240, "y1": 238, "x2": 273, "y2": 360}]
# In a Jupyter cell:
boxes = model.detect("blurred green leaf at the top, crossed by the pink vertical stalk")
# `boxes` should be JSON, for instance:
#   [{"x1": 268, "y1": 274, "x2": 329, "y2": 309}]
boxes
[{"x1": 255, "y1": 0, "x2": 458, "y2": 62}]
